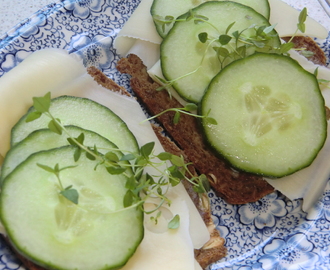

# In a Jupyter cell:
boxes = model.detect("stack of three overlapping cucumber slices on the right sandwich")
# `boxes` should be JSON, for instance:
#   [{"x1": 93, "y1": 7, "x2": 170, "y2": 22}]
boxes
[{"x1": 151, "y1": 0, "x2": 327, "y2": 178}]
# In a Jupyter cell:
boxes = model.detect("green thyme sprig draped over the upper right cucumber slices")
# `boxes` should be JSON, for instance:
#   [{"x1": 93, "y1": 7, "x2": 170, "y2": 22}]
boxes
[{"x1": 153, "y1": 8, "x2": 313, "y2": 103}]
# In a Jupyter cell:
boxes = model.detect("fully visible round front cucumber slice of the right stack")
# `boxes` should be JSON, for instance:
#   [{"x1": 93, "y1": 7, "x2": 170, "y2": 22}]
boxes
[{"x1": 201, "y1": 53, "x2": 327, "y2": 177}]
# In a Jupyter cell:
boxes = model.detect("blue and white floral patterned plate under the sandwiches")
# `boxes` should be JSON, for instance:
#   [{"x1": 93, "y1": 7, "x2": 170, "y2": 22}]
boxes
[{"x1": 0, "y1": 0, "x2": 330, "y2": 270}]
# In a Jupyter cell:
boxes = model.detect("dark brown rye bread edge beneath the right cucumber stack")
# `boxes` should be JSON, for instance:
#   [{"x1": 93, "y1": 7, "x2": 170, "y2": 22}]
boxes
[{"x1": 117, "y1": 54, "x2": 274, "y2": 204}]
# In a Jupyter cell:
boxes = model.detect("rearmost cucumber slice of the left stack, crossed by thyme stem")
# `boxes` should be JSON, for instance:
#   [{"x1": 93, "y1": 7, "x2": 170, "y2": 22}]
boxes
[{"x1": 11, "y1": 96, "x2": 139, "y2": 153}]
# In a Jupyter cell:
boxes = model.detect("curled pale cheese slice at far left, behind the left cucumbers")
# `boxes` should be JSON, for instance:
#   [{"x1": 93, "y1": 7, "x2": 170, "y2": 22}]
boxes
[{"x1": 0, "y1": 49, "x2": 86, "y2": 156}]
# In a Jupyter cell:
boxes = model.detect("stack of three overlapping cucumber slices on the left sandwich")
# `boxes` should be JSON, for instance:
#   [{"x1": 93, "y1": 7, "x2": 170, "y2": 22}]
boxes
[{"x1": 0, "y1": 96, "x2": 144, "y2": 270}]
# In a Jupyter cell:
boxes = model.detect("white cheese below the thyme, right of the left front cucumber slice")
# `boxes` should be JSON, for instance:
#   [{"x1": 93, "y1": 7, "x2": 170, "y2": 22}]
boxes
[{"x1": 122, "y1": 186, "x2": 195, "y2": 270}]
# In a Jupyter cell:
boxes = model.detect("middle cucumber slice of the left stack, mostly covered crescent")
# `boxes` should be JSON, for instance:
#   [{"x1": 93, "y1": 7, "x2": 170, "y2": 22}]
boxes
[{"x1": 0, "y1": 126, "x2": 122, "y2": 183}]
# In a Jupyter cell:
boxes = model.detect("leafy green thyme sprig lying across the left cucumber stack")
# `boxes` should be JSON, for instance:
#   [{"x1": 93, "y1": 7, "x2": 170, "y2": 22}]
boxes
[{"x1": 26, "y1": 93, "x2": 209, "y2": 227}]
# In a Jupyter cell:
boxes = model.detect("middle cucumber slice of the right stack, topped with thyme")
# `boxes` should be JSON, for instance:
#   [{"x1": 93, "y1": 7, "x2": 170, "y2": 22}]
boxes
[{"x1": 160, "y1": 1, "x2": 280, "y2": 103}]
